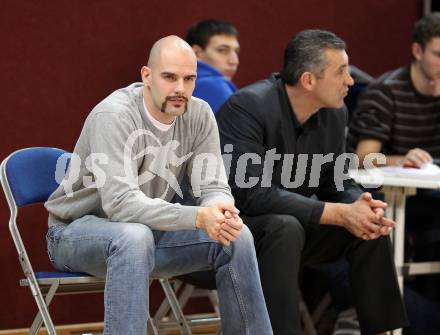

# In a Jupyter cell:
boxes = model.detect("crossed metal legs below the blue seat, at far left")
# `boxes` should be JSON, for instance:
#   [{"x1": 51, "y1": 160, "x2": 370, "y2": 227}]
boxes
[{"x1": 28, "y1": 278, "x2": 59, "y2": 335}]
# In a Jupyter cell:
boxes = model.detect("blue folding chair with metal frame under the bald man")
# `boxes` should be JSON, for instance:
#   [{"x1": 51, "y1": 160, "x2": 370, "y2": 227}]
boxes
[{"x1": 0, "y1": 147, "x2": 191, "y2": 335}]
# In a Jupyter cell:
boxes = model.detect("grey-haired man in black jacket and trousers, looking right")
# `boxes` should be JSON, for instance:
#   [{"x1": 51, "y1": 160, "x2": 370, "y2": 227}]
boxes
[{"x1": 217, "y1": 30, "x2": 406, "y2": 335}]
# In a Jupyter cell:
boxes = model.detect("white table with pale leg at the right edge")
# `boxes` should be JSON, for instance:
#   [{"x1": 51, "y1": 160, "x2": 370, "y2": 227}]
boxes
[{"x1": 350, "y1": 170, "x2": 440, "y2": 334}]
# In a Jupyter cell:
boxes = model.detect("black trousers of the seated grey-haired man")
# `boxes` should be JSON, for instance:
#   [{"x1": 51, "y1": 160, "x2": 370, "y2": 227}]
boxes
[{"x1": 243, "y1": 214, "x2": 407, "y2": 335}]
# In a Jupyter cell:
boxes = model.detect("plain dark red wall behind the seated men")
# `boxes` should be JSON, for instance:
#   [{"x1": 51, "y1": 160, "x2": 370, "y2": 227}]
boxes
[{"x1": 0, "y1": 0, "x2": 422, "y2": 329}]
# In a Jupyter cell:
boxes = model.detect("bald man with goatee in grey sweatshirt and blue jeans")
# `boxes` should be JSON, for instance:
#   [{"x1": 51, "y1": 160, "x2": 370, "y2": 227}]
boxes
[{"x1": 45, "y1": 36, "x2": 272, "y2": 335}]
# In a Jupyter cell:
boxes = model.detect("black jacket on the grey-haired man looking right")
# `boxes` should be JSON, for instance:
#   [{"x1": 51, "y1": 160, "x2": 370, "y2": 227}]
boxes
[{"x1": 217, "y1": 75, "x2": 361, "y2": 224}]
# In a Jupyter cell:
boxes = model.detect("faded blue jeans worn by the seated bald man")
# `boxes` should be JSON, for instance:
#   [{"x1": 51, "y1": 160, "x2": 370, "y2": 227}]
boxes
[{"x1": 47, "y1": 215, "x2": 273, "y2": 335}]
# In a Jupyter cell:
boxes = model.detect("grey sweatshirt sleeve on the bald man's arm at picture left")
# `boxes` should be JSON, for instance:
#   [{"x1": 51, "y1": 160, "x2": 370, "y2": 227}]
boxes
[{"x1": 87, "y1": 112, "x2": 197, "y2": 230}]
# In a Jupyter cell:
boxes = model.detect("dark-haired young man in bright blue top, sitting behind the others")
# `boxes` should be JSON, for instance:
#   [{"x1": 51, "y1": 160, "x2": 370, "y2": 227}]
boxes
[{"x1": 186, "y1": 20, "x2": 240, "y2": 113}]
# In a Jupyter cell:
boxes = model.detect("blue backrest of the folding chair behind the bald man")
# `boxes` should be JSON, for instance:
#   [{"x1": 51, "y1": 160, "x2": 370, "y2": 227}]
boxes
[{"x1": 1, "y1": 147, "x2": 70, "y2": 207}]
